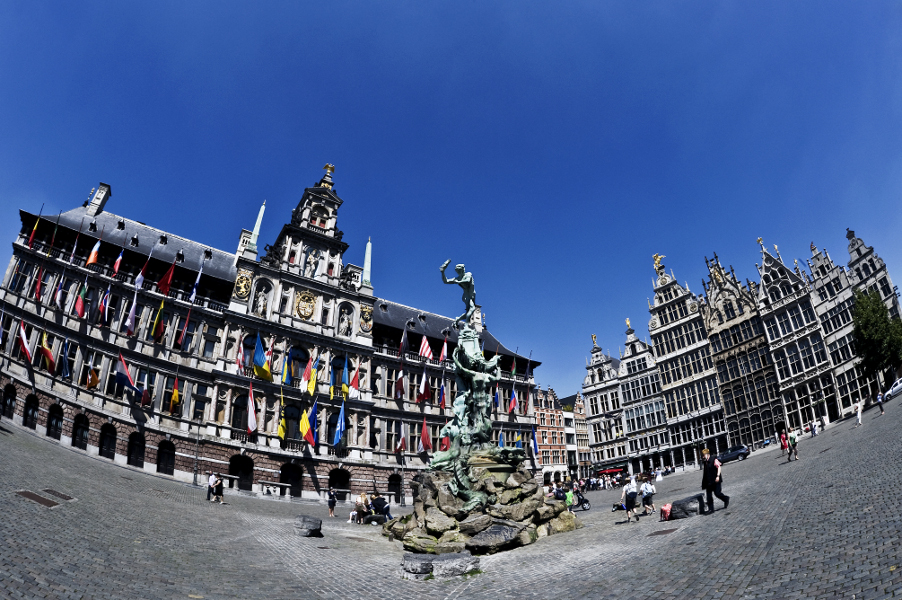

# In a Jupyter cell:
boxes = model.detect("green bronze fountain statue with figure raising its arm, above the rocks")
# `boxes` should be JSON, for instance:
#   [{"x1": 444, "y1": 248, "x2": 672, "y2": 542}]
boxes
[{"x1": 429, "y1": 261, "x2": 526, "y2": 511}]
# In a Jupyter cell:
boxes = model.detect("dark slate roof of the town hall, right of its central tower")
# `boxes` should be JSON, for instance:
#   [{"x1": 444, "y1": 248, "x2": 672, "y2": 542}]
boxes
[{"x1": 373, "y1": 298, "x2": 542, "y2": 364}]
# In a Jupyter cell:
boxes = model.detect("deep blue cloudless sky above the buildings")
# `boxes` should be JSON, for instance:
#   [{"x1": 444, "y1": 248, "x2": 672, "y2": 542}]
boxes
[{"x1": 0, "y1": 0, "x2": 902, "y2": 395}]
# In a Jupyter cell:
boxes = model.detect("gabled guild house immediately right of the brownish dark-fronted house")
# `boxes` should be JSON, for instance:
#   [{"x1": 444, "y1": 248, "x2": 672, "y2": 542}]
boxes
[{"x1": 755, "y1": 238, "x2": 835, "y2": 428}]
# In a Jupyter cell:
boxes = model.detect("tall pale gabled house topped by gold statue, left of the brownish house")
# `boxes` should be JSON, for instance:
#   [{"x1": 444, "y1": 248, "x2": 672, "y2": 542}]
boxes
[{"x1": 648, "y1": 255, "x2": 726, "y2": 465}]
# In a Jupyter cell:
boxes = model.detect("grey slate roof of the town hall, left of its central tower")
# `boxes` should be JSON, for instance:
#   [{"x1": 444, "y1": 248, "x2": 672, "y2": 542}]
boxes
[{"x1": 19, "y1": 206, "x2": 237, "y2": 282}]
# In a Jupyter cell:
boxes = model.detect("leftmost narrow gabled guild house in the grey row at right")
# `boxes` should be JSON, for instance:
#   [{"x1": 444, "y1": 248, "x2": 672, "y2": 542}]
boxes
[{"x1": 582, "y1": 335, "x2": 627, "y2": 469}]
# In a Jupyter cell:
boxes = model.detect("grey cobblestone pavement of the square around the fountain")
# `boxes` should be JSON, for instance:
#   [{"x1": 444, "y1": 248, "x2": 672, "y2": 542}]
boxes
[{"x1": 0, "y1": 403, "x2": 902, "y2": 600}]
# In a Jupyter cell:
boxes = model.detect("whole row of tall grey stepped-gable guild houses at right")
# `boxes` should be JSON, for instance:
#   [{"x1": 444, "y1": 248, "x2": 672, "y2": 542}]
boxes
[{"x1": 582, "y1": 230, "x2": 900, "y2": 472}]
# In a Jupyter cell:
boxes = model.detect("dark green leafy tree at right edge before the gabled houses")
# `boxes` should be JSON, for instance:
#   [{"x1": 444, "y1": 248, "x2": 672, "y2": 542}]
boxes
[{"x1": 852, "y1": 290, "x2": 902, "y2": 377}]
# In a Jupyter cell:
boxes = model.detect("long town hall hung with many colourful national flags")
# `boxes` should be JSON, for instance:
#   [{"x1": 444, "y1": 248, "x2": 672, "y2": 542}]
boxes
[{"x1": 0, "y1": 166, "x2": 539, "y2": 498}]
